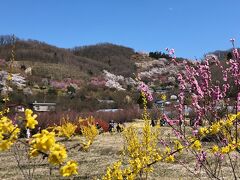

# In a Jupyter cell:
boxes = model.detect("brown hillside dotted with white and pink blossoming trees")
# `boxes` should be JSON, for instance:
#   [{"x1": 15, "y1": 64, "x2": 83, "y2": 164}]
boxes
[{"x1": 0, "y1": 37, "x2": 188, "y2": 111}]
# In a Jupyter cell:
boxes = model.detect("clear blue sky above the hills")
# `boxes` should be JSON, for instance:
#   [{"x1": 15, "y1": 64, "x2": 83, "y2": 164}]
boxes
[{"x1": 0, "y1": 0, "x2": 240, "y2": 58}]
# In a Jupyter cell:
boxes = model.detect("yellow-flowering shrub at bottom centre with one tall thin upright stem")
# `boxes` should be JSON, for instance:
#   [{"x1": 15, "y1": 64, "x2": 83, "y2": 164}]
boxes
[{"x1": 102, "y1": 91, "x2": 175, "y2": 180}]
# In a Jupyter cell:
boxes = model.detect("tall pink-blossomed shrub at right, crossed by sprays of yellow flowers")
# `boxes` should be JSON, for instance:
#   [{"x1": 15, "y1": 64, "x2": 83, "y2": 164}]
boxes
[{"x1": 161, "y1": 39, "x2": 240, "y2": 179}]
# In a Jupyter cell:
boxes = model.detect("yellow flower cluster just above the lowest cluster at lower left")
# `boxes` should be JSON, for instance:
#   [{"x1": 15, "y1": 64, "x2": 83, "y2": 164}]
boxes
[{"x1": 48, "y1": 144, "x2": 67, "y2": 165}]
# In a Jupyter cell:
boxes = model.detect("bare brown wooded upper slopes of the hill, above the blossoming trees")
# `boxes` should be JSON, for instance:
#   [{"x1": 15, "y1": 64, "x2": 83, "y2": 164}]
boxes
[{"x1": 0, "y1": 40, "x2": 134, "y2": 75}]
